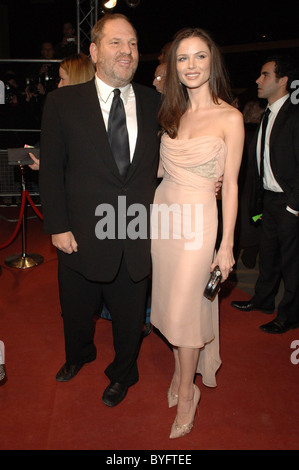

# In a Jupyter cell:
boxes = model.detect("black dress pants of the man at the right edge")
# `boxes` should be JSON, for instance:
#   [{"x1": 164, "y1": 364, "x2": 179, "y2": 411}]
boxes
[{"x1": 253, "y1": 191, "x2": 299, "y2": 322}]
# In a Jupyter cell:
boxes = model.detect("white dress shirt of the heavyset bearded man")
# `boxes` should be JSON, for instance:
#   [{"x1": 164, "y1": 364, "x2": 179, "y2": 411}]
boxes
[{"x1": 95, "y1": 74, "x2": 138, "y2": 161}]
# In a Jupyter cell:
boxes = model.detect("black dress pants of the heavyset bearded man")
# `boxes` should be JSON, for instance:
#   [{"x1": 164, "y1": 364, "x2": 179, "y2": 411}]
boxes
[{"x1": 58, "y1": 258, "x2": 148, "y2": 387}]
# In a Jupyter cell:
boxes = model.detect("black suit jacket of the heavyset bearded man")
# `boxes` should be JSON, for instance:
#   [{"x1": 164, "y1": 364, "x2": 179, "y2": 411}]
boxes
[{"x1": 40, "y1": 80, "x2": 160, "y2": 282}]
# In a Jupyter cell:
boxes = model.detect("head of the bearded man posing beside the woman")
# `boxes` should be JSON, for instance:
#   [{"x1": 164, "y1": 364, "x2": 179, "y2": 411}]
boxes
[{"x1": 90, "y1": 18, "x2": 138, "y2": 88}]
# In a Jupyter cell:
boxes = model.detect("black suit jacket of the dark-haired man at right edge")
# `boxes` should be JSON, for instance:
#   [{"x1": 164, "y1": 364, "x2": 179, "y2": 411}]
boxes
[{"x1": 249, "y1": 98, "x2": 299, "y2": 217}]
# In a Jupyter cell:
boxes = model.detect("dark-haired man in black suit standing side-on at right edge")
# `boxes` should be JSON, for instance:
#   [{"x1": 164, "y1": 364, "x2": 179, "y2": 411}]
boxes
[{"x1": 232, "y1": 56, "x2": 299, "y2": 333}]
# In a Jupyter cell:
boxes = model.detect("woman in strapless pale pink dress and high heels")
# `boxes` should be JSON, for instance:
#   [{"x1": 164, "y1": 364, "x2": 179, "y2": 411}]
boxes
[{"x1": 151, "y1": 28, "x2": 244, "y2": 438}]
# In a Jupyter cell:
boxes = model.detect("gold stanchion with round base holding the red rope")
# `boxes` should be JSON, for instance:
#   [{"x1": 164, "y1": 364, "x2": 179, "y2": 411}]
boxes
[{"x1": 5, "y1": 165, "x2": 44, "y2": 269}]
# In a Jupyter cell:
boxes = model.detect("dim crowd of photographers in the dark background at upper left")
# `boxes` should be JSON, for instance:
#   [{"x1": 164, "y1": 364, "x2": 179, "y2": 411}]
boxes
[{"x1": 0, "y1": 21, "x2": 78, "y2": 148}]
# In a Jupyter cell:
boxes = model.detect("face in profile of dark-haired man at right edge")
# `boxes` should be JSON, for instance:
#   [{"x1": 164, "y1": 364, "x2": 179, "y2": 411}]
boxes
[{"x1": 256, "y1": 62, "x2": 285, "y2": 104}]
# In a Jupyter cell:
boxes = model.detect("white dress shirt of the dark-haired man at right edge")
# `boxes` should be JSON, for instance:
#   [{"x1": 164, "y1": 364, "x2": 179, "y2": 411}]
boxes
[{"x1": 256, "y1": 94, "x2": 298, "y2": 215}]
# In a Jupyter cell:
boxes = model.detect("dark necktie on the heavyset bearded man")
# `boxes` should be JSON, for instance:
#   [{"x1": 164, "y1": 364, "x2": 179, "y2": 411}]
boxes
[{"x1": 108, "y1": 88, "x2": 130, "y2": 178}]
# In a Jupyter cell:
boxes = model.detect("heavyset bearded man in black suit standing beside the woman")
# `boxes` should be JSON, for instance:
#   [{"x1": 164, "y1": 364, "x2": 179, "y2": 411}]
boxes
[{"x1": 40, "y1": 14, "x2": 160, "y2": 406}]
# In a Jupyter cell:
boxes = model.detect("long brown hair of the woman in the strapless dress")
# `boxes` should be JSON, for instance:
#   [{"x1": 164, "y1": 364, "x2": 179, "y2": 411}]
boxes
[{"x1": 158, "y1": 28, "x2": 232, "y2": 139}]
